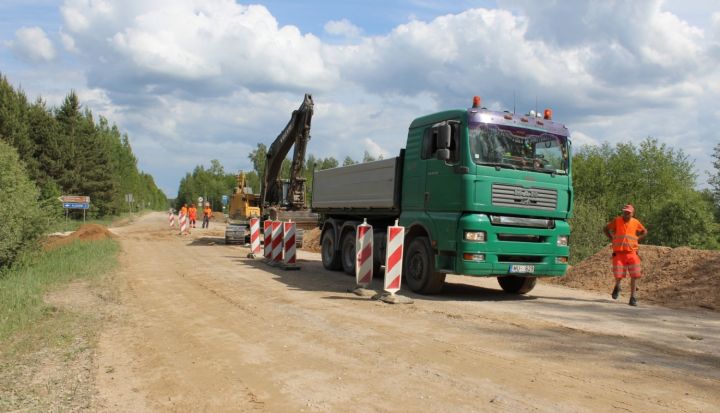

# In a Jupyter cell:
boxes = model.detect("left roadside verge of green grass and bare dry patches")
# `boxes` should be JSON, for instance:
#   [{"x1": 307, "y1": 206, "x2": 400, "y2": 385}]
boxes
[{"x1": 0, "y1": 239, "x2": 120, "y2": 411}]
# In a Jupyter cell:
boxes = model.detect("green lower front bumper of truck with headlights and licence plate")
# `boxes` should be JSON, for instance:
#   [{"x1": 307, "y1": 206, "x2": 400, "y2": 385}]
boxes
[{"x1": 452, "y1": 214, "x2": 570, "y2": 277}]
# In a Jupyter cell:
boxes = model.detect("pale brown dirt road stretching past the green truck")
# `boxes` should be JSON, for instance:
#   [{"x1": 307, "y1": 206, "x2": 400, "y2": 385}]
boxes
[{"x1": 97, "y1": 214, "x2": 720, "y2": 412}]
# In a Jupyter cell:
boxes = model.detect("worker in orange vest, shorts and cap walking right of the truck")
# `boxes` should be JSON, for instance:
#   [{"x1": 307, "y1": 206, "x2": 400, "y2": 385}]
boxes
[{"x1": 604, "y1": 204, "x2": 647, "y2": 306}]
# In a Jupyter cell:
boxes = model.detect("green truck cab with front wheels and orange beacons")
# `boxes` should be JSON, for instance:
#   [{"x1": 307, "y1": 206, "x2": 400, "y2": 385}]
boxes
[{"x1": 400, "y1": 100, "x2": 573, "y2": 293}]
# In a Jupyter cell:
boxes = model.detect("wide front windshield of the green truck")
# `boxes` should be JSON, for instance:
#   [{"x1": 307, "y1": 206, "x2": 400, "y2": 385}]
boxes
[{"x1": 468, "y1": 124, "x2": 568, "y2": 174}]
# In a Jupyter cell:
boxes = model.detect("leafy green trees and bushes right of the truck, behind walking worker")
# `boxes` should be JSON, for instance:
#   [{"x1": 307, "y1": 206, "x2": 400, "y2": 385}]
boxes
[{"x1": 570, "y1": 138, "x2": 720, "y2": 262}]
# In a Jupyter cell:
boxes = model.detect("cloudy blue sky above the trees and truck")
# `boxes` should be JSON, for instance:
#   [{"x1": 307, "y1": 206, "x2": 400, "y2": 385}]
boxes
[{"x1": 0, "y1": 0, "x2": 720, "y2": 198}]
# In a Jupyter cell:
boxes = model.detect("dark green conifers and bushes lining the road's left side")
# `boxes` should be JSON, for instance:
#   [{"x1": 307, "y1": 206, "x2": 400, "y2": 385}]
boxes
[{"x1": 0, "y1": 74, "x2": 167, "y2": 266}]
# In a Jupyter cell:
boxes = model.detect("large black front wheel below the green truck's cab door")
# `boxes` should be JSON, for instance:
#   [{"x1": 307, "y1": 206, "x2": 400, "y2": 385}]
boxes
[{"x1": 403, "y1": 237, "x2": 445, "y2": 294}]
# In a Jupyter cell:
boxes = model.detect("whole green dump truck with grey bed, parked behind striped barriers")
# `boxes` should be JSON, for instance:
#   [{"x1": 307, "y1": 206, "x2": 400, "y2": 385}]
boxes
[{"x1": 312, "y1": 97, "x2": 573, "y2": 294}]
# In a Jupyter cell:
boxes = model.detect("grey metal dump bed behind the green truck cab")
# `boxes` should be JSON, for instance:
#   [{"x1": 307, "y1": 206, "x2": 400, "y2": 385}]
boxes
[{"x1": 312, "y1": 157, "x2": 401, "y2": 213}]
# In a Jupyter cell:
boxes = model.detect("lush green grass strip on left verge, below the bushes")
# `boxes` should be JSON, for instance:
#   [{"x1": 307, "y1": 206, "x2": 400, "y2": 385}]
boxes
[{"x1": 0, "y1": 239, "x2": 120, "y2": 342}]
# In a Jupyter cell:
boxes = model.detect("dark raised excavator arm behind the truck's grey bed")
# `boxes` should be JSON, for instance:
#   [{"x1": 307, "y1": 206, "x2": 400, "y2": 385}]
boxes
[{"x1": 260, "y1": 93, "x2": 314, "y2": 210}]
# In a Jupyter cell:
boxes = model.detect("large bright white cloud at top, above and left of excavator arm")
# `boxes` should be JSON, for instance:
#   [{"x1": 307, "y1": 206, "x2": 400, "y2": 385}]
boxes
[{"x1": 63, "y1": 0, "x2": 338, "y2": 95}]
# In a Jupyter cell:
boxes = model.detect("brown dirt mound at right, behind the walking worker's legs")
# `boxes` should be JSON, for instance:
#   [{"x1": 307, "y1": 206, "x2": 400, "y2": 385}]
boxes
[{"x1": 547, "y1": 245, "x2": 720, "y2": 311}]
